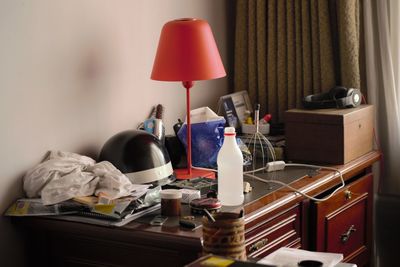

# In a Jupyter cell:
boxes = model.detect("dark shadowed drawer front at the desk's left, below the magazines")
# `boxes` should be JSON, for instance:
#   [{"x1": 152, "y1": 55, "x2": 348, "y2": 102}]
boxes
[{"x1": 46, "y1": 234, "x2": 197, "y2": 267}]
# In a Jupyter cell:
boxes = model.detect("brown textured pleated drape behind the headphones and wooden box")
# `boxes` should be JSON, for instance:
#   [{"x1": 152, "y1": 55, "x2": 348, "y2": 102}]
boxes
[{"x1": 234, "y1": 0, "x2": 363, "y2": 122}]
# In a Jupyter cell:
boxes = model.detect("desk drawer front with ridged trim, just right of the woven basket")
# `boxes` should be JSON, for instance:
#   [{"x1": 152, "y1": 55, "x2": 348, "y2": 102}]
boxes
[{"x1": 245, "y1": 206, "x2": 301, "y2": 257}]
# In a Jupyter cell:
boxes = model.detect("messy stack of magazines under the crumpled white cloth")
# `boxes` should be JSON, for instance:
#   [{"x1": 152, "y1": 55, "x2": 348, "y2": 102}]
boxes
[{"x1": 5, "y1": 187, "x2": 160, "y2": 226}]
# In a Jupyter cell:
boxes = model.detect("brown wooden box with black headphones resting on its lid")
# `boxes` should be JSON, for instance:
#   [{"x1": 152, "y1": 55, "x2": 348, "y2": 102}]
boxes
[{"x1": 285, "y1": 105, "x2": 373, "y2": 164}]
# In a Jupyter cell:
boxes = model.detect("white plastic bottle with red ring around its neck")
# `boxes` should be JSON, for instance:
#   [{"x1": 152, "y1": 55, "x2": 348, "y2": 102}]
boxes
[{"x1": 217, "y1": 127, "x2": 244, "y2": 206}]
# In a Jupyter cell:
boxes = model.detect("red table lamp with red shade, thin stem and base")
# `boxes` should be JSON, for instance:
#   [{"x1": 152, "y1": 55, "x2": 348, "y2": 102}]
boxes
[{"x1": 151, "y1": 18, "x2": 226, "y2": 179}]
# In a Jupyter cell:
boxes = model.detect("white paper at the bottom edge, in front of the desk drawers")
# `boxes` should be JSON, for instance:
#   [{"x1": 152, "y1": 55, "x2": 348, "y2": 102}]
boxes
[{"x1": 258, "y1": 247, "x2": 343, "y2": 267}]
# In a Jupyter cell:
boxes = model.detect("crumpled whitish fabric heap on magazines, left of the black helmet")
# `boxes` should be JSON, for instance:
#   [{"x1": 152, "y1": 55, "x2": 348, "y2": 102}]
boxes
[{"x1": 23, "y1": 151, "x2": 138, "y2": 205}]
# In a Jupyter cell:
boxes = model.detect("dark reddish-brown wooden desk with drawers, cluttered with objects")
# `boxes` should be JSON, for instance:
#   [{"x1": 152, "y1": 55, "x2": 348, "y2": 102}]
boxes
[{"x1": 14, "y1": 152, "x2": 380, "y2": 266}]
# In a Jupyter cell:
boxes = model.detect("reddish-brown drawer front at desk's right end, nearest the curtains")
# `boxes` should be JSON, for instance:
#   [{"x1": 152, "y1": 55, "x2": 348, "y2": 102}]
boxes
[{"x1": 311, "y1": 174, "x2": 372, "y2": 266}]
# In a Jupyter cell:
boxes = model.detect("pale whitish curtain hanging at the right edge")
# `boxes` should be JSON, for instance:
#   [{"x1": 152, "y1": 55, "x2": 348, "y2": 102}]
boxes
[{"x1": 363, "y1": 0, "x2": 400, "y2": 195}]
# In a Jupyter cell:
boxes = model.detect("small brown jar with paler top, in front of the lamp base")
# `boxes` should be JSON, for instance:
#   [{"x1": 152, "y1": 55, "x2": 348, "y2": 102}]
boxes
[{"x1": 160, "y1": 189, "x2": 182, "y2": 216}]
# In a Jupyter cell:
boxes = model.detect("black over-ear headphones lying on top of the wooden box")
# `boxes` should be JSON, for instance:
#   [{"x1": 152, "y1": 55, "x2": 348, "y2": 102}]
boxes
[{"x1": 303, "y1": 86, "x2": 361, "y2": 109}]
